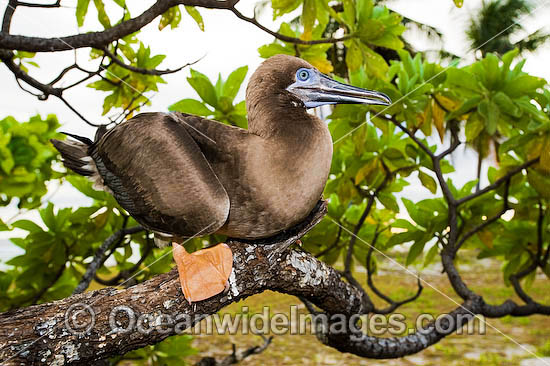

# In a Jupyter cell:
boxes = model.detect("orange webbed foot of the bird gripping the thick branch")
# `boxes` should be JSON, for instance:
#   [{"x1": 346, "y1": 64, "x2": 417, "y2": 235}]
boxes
[{"x1": 172, "y1": 242, "x2": 233, "y2": 303}]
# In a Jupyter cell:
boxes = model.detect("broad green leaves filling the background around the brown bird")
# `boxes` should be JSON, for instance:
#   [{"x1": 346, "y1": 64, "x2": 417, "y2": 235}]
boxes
[{"x1": 0, "y1": 0, "x2": 550, "y2": 365}]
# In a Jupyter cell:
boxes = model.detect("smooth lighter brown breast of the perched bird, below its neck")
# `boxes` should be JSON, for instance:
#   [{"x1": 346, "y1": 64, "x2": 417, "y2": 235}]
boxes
[{"x1": 222, "y1": 123, "x2": 332, "y2": 239}]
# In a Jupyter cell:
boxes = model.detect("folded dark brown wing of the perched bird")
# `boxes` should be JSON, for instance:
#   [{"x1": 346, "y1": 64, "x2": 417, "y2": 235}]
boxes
[{"x1": 90, "y1": 113, "x2": 229, "y2": 237}]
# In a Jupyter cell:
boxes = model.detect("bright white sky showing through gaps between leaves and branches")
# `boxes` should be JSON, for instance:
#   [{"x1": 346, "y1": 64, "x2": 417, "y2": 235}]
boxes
[{"x1": 0, "y1": 0, "x2": 550, "y2": 264}]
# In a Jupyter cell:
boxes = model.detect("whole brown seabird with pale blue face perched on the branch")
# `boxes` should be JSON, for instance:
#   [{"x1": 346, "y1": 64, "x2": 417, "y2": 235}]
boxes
[{"x1": 52, "y1": 55, "x2": 391, "y2": 302}]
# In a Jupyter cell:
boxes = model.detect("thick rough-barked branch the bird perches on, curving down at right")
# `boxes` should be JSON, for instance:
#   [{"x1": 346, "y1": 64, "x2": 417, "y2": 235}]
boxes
[{"x1": 0, "y1": 201, "x2": 520, "y2": 365}]
